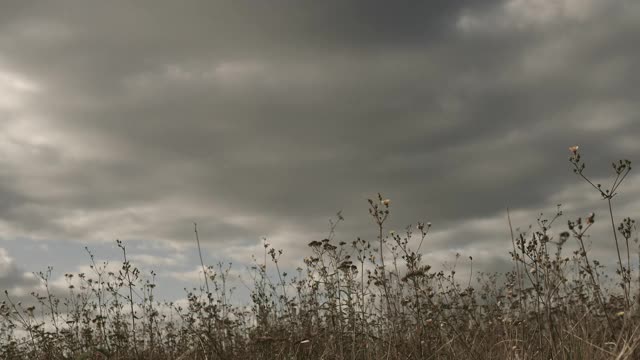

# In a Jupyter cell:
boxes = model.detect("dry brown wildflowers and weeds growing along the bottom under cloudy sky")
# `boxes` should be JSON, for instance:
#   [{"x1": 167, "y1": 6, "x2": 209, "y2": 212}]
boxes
[{"x1": 0, "y1": 147, "x2": 640, "y2": 360}]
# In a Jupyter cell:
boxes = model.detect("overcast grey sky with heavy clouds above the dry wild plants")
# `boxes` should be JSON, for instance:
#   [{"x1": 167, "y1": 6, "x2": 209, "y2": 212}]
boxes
[{"x1": 0, "y1": 0, "x2": 640, "y2": 298}]
